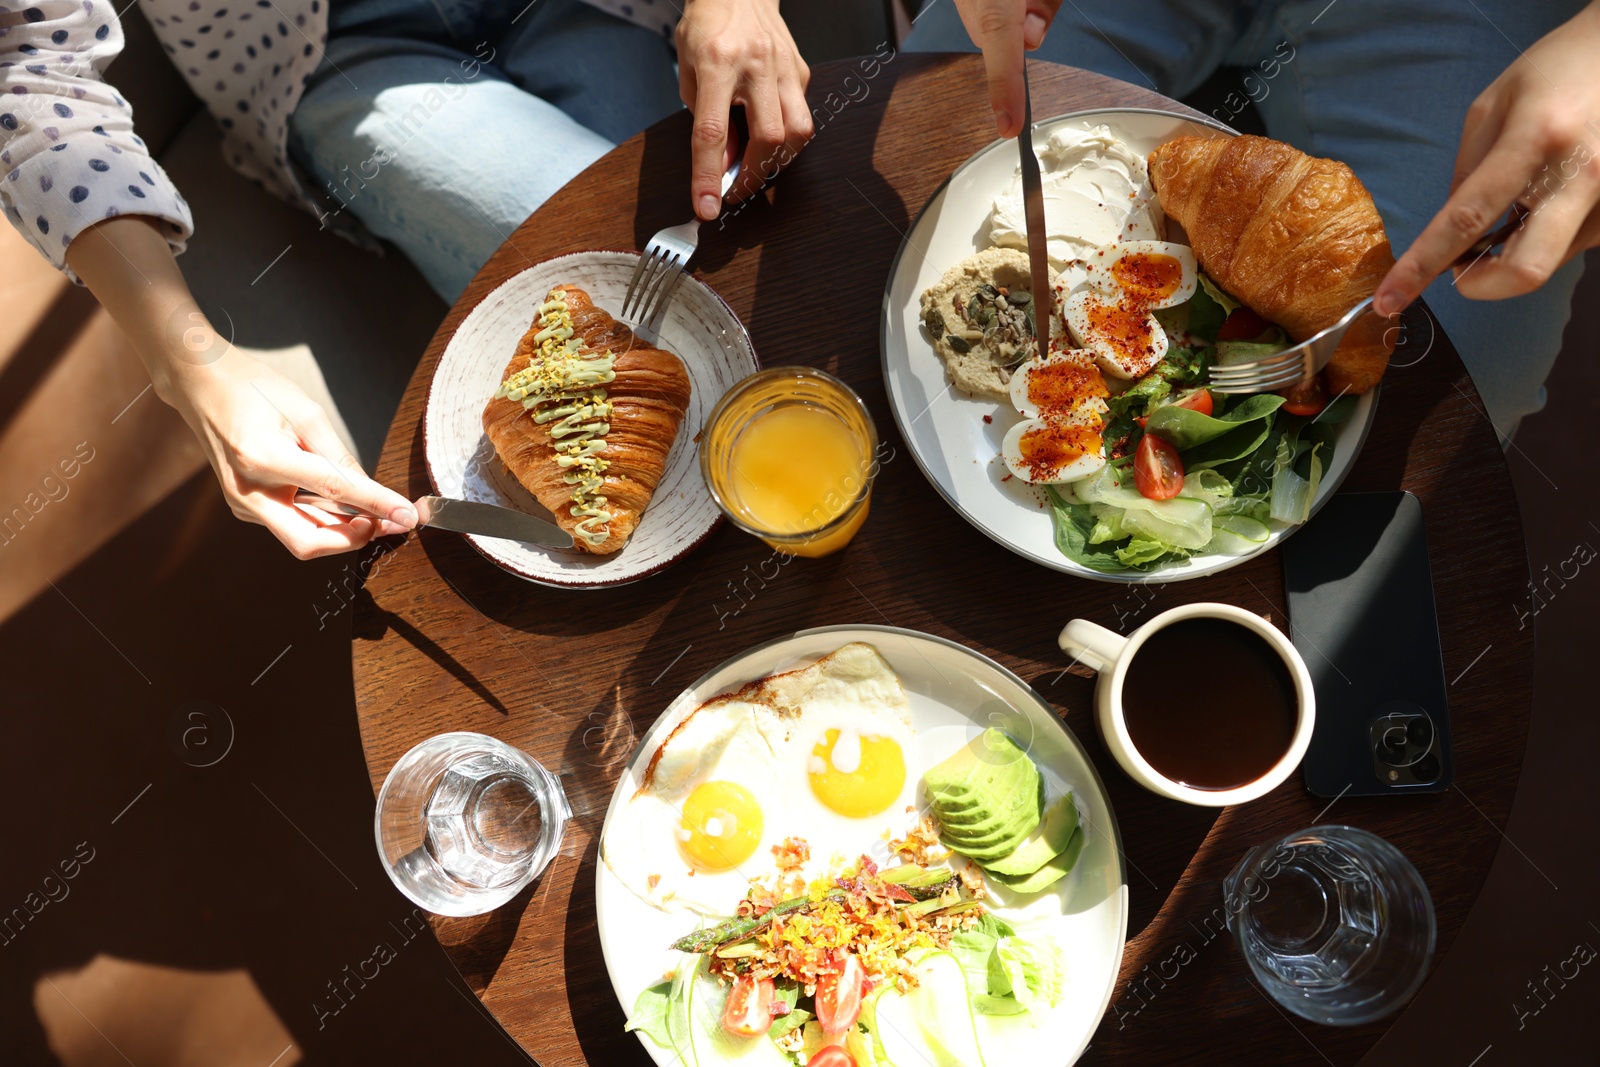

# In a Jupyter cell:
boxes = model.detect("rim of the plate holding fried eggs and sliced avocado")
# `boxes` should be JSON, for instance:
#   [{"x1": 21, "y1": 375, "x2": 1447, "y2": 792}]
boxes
[{"x1": 595, "y1": 622, "x2": 1130, "y2": 1067}]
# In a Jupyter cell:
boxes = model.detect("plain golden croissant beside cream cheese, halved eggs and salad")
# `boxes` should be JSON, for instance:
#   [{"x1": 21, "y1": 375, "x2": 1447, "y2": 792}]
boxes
[{"x1": 1149, "y1": 136, "x2": 1395, "y2": 394}]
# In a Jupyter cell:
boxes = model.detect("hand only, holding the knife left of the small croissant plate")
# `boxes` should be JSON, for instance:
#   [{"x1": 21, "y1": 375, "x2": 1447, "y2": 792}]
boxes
[{"x1": 158, "y1": 351, "x2": 416, "y2": 560}]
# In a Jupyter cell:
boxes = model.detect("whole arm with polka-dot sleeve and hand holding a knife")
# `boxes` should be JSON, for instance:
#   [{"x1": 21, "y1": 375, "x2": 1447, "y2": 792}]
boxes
[{"x1": 0, "y1": 0, "x2": 410, "y2": 557}]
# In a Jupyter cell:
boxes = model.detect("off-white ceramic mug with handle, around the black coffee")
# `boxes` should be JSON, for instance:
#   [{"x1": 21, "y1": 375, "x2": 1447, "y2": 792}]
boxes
[{"x1": 1061, "y1": 603, "x2": 1317, "y2": 808}]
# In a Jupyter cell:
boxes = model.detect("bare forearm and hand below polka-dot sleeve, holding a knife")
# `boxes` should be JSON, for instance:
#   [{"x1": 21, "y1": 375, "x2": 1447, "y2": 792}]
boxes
[{"x1": 67, "y1": 214, "x2": 416, "y2": 560}]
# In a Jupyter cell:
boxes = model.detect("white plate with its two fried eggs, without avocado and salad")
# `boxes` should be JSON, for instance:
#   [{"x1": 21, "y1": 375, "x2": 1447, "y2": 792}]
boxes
[{"x1": 595, "y1": 625, "x2": 1128, "y2": 1065}]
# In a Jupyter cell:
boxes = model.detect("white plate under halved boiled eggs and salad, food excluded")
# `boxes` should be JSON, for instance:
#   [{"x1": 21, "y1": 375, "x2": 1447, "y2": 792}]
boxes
[{"x1": 882, "y1": 109, "x2": 1378, "y2": 582}]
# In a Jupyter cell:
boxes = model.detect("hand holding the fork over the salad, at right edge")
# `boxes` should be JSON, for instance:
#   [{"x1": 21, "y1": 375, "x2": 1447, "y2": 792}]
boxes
[{"x1": 1373, "y1": 3, "x2": 1600, "y2": 315}]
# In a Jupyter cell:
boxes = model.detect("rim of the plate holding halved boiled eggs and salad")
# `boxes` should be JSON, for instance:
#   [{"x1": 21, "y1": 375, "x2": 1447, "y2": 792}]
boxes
[{"x1": 878, "y1": 107, "x2": 1382, "y2": 585}]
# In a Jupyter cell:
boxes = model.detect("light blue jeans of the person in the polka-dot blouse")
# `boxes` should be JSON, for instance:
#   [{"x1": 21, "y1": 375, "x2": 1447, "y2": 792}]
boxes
[{"x1": 290, "y1": 0, "x2": 686, "y2": 302}]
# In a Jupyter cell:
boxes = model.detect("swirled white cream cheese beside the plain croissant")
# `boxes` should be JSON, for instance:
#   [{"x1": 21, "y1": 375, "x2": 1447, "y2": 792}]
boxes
[{"x1": 989, "y1": 126, "x2": 1165, "y2": 291}]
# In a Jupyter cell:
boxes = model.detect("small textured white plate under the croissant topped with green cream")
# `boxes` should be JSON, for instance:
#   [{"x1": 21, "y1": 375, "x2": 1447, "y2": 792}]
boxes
[{"x1": 422, "y1": 251, "x2": 757, "y2": 587}]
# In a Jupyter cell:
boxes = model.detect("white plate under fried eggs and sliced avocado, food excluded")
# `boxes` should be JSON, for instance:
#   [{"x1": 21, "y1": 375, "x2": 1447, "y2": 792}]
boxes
[{"x1": 595, "y1": 625, "x2": 1128, "y2": 1067}]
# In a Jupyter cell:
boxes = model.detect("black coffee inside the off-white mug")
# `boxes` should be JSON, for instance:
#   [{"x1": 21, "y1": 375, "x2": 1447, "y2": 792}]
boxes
[{"x1": 1122, "y1": 619, "x2": 1299, "y2": 789}]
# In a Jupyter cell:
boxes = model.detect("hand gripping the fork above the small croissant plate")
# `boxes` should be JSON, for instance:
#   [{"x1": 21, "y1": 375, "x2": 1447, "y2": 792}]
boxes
[{"x1": 677, "y1": 0, "x2": 811, "y2": 222}]
